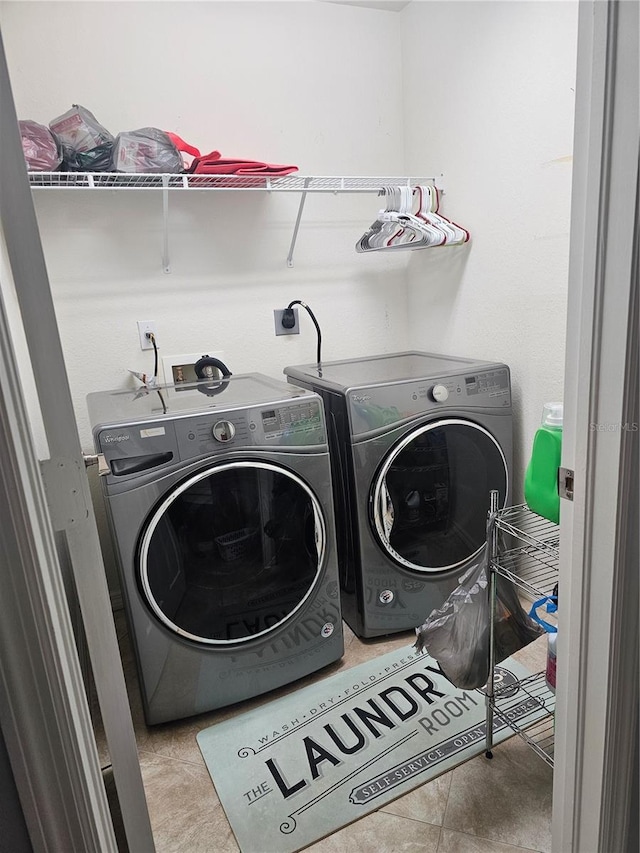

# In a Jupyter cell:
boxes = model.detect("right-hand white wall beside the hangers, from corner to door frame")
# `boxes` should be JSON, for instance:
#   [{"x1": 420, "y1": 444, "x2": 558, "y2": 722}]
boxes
[{"x1": 401, "y1": 0, "x2": 578, "y2": 501}]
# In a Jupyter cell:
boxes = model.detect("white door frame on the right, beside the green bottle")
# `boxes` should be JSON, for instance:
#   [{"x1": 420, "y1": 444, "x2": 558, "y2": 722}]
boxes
[{"x1": 552, "y1": 0, "x2": 640, "y2": 853}]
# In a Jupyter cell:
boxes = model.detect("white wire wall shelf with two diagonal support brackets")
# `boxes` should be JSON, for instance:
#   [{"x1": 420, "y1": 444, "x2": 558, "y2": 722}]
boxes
[{"x1": 28, "y1": 172, "x2": 443, "y2": 272}]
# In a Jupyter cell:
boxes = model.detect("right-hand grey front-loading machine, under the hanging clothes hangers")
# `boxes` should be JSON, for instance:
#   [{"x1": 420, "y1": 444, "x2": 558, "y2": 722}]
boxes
[{"x1": 284, "y1": 351, "x2": 512, "y2": 637}]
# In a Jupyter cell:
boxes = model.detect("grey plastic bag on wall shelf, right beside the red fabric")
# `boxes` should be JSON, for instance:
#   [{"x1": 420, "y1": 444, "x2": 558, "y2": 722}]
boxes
[{"x1": 112, "y1": 127, "x2": 200, "y2": 175}]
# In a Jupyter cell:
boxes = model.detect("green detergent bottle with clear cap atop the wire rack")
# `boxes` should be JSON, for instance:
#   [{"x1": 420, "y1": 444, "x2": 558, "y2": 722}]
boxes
[{"x1": 524, "y1": 403, "x2": 562, "y2": 524}]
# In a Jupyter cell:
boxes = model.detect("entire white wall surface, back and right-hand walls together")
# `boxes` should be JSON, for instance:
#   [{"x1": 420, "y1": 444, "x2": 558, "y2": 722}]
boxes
[{"x1": 0, "y1": 0, "x2": 577, "y2": 596}]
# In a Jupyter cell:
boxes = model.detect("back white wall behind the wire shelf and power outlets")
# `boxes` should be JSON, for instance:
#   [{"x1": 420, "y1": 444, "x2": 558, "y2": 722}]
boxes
[{"x1": 0, "y1": 2, "x2": 407, "y2": 447}]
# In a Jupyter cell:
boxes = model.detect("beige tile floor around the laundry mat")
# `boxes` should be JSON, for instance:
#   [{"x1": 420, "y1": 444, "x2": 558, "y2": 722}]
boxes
[{"x1": 93, "y1": 611, "x2": 552, "y2": 853}]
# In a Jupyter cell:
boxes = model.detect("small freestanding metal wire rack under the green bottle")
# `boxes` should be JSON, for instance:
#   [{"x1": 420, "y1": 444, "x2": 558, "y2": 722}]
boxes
[{"x1": 485, "y1": 492, "x2": 559, "y2": 767}]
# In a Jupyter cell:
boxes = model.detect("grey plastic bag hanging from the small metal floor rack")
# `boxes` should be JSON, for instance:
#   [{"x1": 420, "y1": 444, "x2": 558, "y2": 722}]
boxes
[{"x1": 415, "y1": 545, "x2": 543, "y2": 690}]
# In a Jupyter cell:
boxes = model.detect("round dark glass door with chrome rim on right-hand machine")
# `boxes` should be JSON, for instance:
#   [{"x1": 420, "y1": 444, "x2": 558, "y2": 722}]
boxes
[{"x1": 371, "y1": 419, "x2": 508, "y2": 572}]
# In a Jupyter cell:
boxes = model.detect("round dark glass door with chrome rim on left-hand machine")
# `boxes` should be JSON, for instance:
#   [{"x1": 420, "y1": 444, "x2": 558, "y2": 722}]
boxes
[{"x1": 138, "y1": 462, "x2": 326, "y2": 645}]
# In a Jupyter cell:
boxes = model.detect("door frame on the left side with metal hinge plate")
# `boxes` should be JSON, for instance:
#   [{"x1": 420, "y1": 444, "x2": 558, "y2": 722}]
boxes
[{"x1": 0, "y1": 28, "x2": 155, "y2": 853}]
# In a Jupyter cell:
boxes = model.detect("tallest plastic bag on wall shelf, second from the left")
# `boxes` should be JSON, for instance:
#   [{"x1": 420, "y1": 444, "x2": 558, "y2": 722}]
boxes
[{"x1": 49, "y1": 104, "x2": 113, "y2": 172}]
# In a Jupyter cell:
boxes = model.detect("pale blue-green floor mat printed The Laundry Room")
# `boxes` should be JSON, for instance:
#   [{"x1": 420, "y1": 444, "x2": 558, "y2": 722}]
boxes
[{"x1": 197, "y1": 646, "x2": 547, "y2": 853}]
